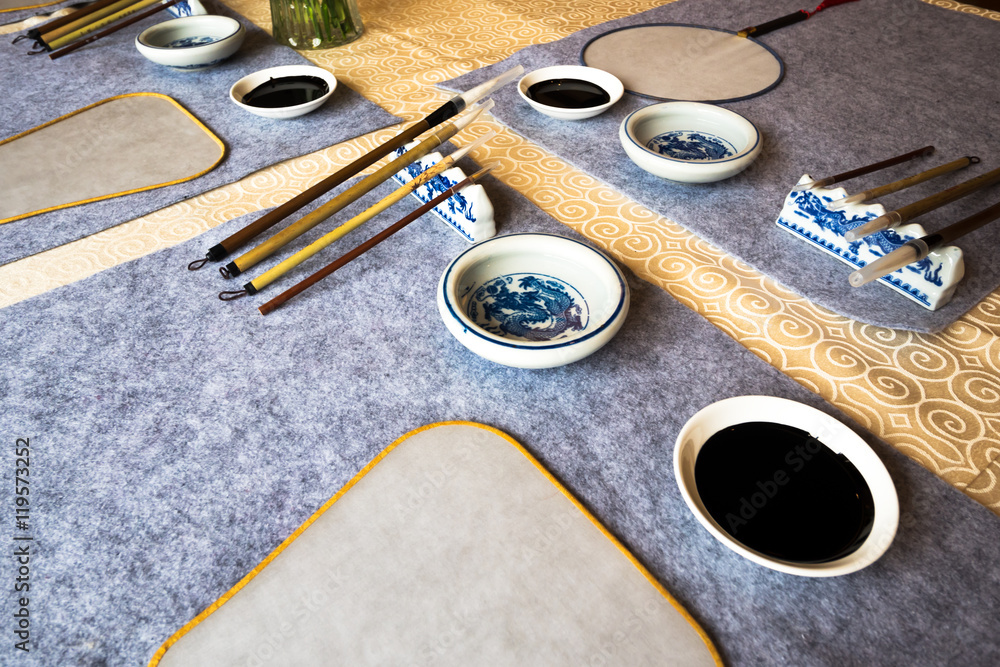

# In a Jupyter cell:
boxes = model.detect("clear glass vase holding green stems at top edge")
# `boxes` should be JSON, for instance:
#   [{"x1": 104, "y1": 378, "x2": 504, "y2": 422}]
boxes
[{"x1": 271, "y1": 0, "x2": 365, "y2": 49}]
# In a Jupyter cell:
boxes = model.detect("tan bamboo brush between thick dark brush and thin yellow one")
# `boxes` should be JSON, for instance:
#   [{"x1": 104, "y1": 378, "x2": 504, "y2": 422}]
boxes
[{"x1": 222, "y1": 100, "x2": 493, "y2": 278}]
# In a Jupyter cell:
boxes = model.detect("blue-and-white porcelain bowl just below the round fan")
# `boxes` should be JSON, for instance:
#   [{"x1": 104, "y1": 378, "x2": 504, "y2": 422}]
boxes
[{"x1": 618, "y1": 102, "x2": 761, "y2": 183}]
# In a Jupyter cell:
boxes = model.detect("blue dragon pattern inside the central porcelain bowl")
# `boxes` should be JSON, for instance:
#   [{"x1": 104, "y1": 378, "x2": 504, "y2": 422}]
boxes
[{"x1": 467, "y1": 274, "x2": 589, "y2": 341}]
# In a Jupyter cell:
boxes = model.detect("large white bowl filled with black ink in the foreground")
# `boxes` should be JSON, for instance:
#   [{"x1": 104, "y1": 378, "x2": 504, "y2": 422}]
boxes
[{"x1": 674, "y1": 396, "x2": 899, "y2": 577}]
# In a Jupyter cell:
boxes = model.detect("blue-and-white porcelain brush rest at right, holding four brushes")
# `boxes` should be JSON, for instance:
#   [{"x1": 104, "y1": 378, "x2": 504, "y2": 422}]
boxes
[{"x1": 776, "y1": 174, "x2": 965, "y2": 310}]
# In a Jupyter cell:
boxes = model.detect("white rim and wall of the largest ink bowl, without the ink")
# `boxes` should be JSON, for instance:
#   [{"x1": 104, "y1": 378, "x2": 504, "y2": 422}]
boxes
[{"x1": 674, "y1": 396, "x2": 899, "y2": 577}]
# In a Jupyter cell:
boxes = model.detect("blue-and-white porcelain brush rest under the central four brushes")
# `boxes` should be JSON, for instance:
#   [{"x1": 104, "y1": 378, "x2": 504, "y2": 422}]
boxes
[{"x1": 393, "y1": 141, "x2": 497, "y2": 243}]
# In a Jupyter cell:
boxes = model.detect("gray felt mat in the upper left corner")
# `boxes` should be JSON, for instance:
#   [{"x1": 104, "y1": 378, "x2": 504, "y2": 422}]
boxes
[{"x1": 0, "y1": 2, "x2": 398, "y2": 264}]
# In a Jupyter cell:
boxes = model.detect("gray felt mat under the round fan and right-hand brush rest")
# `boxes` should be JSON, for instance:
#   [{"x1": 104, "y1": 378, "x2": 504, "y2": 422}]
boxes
[{"x1": 444, "y1": 0, "x2": 1000, "y2": 331}]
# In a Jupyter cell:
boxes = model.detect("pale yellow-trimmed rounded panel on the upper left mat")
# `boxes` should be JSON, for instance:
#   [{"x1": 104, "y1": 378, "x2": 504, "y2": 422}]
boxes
[{"x1": 0, "y1": 93, "x2": 226, "y2": 223}]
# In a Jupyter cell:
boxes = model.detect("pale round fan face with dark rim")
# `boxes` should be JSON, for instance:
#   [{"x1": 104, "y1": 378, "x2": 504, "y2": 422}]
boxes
[{"x1": 580, "y1": 23, "x2": 785, "y2": 103}]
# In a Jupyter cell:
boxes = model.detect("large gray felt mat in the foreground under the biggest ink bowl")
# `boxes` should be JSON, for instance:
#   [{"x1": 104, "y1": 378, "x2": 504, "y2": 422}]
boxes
[{"x1": 0, "y1": 174, "x2": 1000, "y2": 666}]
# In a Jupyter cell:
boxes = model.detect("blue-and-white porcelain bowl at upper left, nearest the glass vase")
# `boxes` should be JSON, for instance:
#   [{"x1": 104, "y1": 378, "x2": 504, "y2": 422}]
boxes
[{"x1": 135, "y1": 14, "x2": 246, "y2": 72}]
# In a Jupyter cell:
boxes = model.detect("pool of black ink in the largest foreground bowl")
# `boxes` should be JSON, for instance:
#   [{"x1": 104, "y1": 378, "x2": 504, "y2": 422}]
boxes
[{"x1": 694, "y1": 422, "x2": 875, "y2": 563}]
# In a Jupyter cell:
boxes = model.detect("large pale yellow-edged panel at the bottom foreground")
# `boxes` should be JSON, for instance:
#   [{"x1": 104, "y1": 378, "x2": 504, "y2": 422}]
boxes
[{"x1": 150, "y1": 422, "x2": 721, "y2": 667}]
